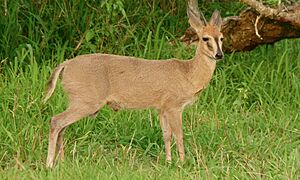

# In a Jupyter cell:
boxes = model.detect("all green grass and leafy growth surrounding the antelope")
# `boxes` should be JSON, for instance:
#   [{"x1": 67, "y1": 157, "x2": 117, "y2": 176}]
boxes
[{"x1": 0, "y1": 0, "x2": 300, "y2": 179}]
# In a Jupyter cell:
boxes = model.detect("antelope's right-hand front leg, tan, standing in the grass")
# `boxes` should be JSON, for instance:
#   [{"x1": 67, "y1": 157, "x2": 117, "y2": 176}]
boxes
[{"x1": 166, "y1": 108, "x2": 185, "y2": 161}]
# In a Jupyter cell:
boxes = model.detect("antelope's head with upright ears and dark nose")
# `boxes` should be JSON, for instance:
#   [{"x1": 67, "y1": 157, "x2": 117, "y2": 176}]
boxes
[{"x1": 187, "y1": 4, "x2": 224, "y2": 60}]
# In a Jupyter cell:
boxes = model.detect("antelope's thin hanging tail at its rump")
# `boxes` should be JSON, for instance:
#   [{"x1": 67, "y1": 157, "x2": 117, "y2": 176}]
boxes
[{"x1": 44, "y1": 64, "x2": 65, "y2": 103}]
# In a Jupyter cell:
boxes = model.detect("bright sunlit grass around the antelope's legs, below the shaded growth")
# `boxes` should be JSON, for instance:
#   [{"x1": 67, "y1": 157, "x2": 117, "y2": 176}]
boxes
[{"x1": 0, "y1": 40, "x2": 300, "y2": 179}]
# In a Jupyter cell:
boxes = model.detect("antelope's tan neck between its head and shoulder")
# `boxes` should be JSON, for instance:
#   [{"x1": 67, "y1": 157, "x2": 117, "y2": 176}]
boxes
[{"x1": 189, "y1": 43, "x2": 216, "y2": 91}]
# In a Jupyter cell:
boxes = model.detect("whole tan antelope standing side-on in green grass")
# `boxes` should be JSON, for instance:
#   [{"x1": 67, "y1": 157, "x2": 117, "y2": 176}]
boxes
[{"x1": 45, "y1": 3, "x2": 223, "y2": 167}]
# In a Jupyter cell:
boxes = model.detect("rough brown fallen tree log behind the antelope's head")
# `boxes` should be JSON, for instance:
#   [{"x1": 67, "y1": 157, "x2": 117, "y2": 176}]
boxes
[{"x1": 180, "y1": 0, "x2": 300, "y2": 53}]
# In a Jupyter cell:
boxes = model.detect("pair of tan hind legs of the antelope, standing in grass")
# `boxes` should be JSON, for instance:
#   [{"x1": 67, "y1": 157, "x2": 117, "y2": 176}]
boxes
[{"x1": 46, "y1": 101, "x2": 101, "y2": 167}]
